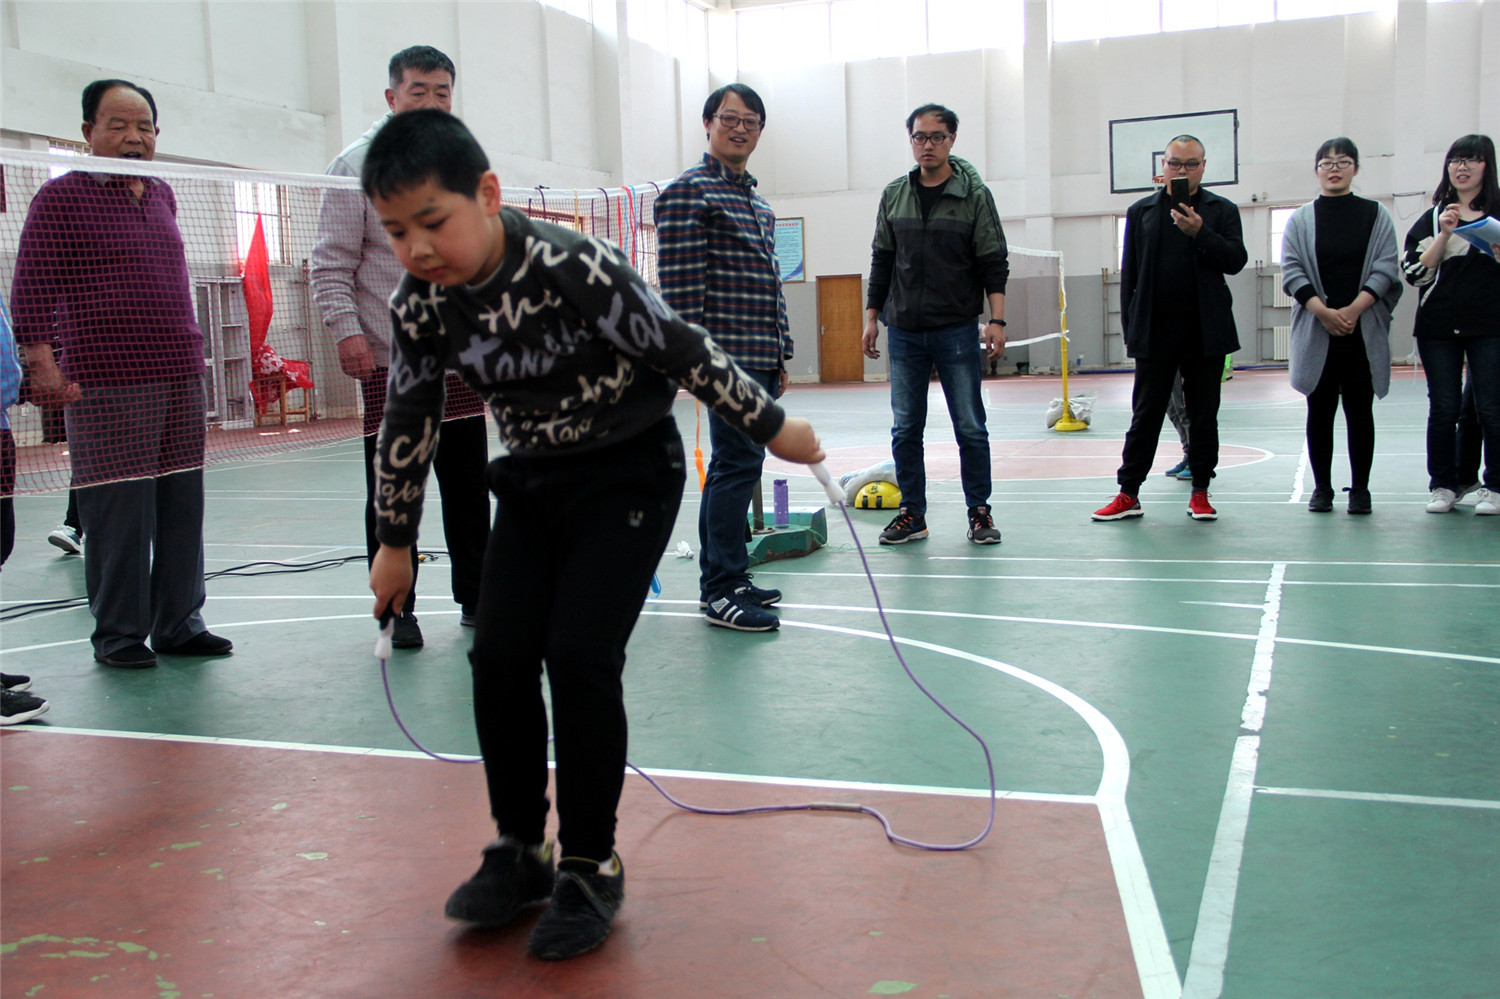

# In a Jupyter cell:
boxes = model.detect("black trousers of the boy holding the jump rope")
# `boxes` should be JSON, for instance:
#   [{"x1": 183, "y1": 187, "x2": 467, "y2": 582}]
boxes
[{"x1": 470, "y1": 417, "x2": 686, "y2": 861}]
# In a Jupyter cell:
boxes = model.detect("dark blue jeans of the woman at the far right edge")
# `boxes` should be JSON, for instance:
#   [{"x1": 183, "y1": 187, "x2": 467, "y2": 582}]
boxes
[{"x1": 1416, "y1": 336, "x2": 1500, "y2": 492}]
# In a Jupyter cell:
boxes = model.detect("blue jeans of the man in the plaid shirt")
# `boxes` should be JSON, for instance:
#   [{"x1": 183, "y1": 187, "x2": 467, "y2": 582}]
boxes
[{"x1": 698, "y1": 369, "x2": 782, "y2": 600}]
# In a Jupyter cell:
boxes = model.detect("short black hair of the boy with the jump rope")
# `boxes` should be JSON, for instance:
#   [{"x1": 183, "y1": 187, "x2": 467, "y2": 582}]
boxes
[{"x1": 360, "y1": 108, "x2": 489, "y2": 198}]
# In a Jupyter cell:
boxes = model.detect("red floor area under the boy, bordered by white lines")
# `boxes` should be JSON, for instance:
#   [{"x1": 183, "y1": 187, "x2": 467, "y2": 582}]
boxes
[{"x1": 0, "y1": 731, "x2": 1140, "y2": 999}]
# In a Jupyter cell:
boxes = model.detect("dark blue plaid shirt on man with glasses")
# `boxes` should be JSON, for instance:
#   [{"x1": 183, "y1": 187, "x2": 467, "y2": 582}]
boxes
[{"x1": 653, "y1": 153, "x2": 792, "y2": 371}]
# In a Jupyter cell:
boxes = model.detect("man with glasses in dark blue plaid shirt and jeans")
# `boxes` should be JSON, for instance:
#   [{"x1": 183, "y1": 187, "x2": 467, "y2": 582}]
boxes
[{"x1": 654, "y1": 84, "x2": 792, "y2": 632}]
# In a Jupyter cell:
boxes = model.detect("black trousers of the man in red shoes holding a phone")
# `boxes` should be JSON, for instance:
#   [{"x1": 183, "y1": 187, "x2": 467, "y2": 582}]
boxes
[{"x1": 1116, "y1": 344, "x2": 1224, "y2": 497}]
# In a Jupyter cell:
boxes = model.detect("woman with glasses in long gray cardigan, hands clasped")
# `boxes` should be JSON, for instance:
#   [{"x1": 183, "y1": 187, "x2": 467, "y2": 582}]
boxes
[{"x1": 1281, "y1": 138, "x2": 1403, "y2": 513}]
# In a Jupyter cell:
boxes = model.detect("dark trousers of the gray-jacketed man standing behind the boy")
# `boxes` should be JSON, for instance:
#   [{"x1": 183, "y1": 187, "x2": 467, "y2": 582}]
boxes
[{"x1": 360, "y1": 369, "x2": 489, "y2": 614}]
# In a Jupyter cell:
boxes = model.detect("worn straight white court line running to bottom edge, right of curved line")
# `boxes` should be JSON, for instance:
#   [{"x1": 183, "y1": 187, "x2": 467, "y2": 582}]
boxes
[{"x1": 1182, "y1": 564, "x2": 1287, "y2": 999}]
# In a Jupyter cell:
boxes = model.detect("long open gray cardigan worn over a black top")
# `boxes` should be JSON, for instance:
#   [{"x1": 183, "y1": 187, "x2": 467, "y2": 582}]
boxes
[{"x1": 1281, "y1": 195, "x2": 1403, "y2": 399}]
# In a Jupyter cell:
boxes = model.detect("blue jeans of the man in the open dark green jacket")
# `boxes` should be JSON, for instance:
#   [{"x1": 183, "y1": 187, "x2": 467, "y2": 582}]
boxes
[{"x1": 885, "y1": 323, "x2": 990, "y2": 515}]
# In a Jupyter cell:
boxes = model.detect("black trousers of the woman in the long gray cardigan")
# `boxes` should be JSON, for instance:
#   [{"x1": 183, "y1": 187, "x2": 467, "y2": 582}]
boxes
[{"x1": 1307, "y1": 327, "x2": 1376, "y2": 489}]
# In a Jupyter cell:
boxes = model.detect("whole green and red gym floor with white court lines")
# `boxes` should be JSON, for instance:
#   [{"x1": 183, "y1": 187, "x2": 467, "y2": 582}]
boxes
[{"x1": 0, "y1": 368, "x2": 1500, "y2": 999}]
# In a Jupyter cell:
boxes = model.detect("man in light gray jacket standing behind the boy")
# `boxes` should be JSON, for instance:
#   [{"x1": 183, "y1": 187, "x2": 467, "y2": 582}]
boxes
[{"x1": 312, "y1": 45, "x2": 489, "y2": 648}]
